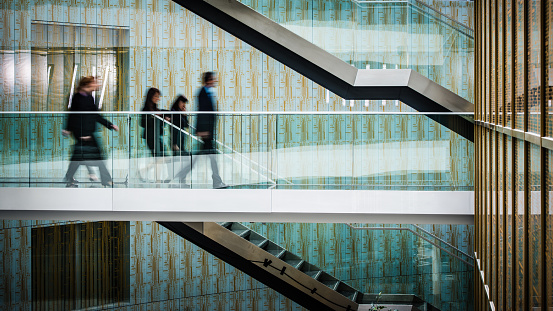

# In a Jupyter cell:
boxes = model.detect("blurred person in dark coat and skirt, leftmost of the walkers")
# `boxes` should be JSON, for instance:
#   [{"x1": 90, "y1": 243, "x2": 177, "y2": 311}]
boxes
[{"x1": 63, "y1": 76, "x2": 119, "y2": 187}]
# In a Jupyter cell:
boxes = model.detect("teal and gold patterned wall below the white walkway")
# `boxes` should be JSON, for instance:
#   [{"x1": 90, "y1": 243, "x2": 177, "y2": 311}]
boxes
[{"x1": 0, "y1": 220, "x2": 474, "y2": 311}]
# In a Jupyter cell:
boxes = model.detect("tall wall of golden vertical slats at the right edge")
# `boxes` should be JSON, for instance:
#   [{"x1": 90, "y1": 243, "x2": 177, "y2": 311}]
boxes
[{"x1": 474, "y1": 0, "x2": 553, "y2": 310}]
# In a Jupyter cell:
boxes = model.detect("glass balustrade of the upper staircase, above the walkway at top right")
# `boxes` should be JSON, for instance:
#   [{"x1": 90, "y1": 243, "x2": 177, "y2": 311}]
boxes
[{"x1": 235, "y1": 0, "x2": 474, "y2": 102}]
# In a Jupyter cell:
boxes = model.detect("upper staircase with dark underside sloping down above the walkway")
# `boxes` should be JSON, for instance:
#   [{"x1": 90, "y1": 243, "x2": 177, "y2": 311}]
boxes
[{"x1": 170, "y1": 0, "x2": 474, "y2": 141}]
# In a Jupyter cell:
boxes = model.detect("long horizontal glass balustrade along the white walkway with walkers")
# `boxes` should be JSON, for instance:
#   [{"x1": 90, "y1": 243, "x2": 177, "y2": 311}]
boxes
[{"x1": 0, "y1": 112, "x2": 474, "y2": 191}]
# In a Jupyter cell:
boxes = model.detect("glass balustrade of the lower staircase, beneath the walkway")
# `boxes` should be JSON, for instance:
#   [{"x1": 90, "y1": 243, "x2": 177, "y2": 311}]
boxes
[{"x1": 243, "y1": 223, "x2": 475, "y2": 311}]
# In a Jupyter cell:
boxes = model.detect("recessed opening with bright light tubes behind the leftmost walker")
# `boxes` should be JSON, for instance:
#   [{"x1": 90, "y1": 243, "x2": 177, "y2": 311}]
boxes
[{"x1": 31, "y1": 21, "x2": 129, "y2": 111}]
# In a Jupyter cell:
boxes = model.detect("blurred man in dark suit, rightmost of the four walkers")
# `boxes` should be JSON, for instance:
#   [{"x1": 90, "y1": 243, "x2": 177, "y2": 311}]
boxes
[{"x1": 176, "y1": 72, "x2": 227, "y2": 188}]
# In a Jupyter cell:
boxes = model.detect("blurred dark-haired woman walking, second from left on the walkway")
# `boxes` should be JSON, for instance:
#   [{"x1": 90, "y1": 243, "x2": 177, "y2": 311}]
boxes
[{"x1": 139, "y1": 88, "x2": 170, "y2": 182}]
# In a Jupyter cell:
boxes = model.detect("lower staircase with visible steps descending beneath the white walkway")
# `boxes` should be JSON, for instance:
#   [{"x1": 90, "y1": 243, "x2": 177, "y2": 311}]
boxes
[{"x1": 159, "y1": 222, "x2": 438, "y2": 311}]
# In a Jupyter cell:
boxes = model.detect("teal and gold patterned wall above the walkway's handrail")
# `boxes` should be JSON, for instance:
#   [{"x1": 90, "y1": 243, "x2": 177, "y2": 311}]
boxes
[{"x1": 0, "y1": 0, "x2": 474, "y2": 111}]
